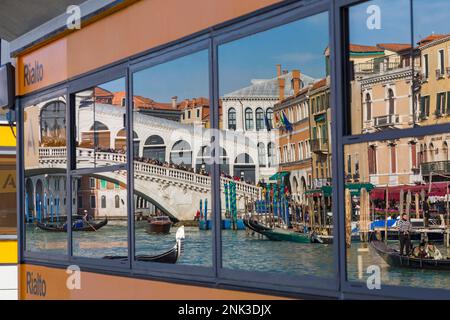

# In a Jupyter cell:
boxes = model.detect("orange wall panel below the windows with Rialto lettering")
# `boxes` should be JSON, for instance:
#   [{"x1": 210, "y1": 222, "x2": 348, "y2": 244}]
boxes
[{"x1": 19, "y1": 264, "x2": 283, "y2": 300}]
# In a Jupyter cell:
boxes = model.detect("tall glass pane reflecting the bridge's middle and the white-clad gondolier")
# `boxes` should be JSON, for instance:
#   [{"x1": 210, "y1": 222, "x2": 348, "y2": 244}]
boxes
[{"x1": 133, "y1": 51, "x2": 212, "y2": 266}]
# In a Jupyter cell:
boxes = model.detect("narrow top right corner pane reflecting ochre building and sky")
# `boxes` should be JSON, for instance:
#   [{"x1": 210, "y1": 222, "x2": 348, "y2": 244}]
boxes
[{"x1": 412, "y1": 0, "x2": 450, "y2": 125}]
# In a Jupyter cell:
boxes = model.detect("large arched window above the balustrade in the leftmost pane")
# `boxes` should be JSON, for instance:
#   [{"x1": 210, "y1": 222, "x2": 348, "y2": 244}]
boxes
[{"x1": 40, "y1": 101, "x2": 66, "y2": 143}]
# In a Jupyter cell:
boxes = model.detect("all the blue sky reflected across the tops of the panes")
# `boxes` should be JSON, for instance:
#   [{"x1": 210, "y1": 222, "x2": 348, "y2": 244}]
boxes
[{"x1": 104, "y1": 0, "x2": 450, "y2": 102}]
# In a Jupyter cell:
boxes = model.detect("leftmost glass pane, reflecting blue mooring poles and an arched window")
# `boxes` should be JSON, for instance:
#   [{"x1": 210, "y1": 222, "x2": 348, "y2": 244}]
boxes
[{"x1": 23, "y1": 97, "x2": 67, "y2": 254}]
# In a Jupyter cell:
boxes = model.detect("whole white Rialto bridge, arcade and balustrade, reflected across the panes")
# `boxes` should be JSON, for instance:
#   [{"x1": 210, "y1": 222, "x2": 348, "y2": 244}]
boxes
[{"x1": 26, "y1": 104, "x2": 268, "y2": 220}]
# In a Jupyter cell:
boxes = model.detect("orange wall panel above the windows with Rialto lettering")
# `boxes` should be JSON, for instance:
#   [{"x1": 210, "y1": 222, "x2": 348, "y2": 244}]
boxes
[{"x1": 17, "y1": 0, "x2": 281, "y2": 95}]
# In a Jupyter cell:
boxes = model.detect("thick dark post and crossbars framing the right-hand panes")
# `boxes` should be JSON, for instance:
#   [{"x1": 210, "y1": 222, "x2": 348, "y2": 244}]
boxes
[{"x1": 333, "y1": 0, "x2": 450, "y2": 299}]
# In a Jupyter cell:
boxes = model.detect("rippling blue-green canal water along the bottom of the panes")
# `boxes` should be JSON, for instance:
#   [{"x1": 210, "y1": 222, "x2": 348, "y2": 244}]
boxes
[{"x1": 26, "y1": 221, "x2": 450, "y2": 289}]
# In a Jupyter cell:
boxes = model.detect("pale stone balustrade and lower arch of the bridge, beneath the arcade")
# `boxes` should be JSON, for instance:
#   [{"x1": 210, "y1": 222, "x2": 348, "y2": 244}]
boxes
[{"x1": 27, "y1": 148, "x2": 260, "y2": 220}]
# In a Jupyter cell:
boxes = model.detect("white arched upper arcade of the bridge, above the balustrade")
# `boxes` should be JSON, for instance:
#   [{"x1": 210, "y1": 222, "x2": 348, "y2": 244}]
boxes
[{"x1": 77, "y1": 103, "x2": 276, "y2": 181}]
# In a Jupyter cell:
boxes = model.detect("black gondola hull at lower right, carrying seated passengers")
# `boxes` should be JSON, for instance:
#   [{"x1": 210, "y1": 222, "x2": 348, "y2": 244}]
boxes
[{"x1": 370, "y1": 240, "x2": 450, "y2": 271}]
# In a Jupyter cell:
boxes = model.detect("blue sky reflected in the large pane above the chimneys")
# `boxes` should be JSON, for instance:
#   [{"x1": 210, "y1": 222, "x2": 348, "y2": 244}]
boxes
[{"x1": 219, "y1": 13, "x2": 329, "y2": 95}]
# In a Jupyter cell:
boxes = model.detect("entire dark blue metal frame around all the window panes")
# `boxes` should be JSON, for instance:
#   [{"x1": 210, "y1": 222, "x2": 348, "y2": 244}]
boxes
[{"x1": 16, "y1": 0, "x2": 450, "y2": 299}]
